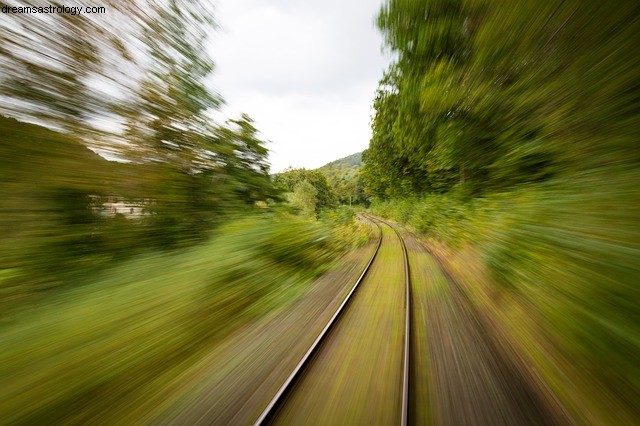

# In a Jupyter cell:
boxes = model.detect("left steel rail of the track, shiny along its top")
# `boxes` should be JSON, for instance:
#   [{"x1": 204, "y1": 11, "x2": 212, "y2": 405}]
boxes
[{"x1": 254, "y1": 216, "x2": 382, "y2": 426}]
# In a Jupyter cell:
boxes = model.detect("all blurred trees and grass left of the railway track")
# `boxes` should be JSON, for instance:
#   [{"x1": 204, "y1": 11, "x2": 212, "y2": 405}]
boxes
[{"x1": 0, "y1": 0, "x2": 370, "y2": 424}]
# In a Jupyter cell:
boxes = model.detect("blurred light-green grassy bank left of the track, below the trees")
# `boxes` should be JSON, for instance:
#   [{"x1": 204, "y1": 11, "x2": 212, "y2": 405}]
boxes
[{"x1": 0, "y1": 215, "x2": 367, "y2": 423}]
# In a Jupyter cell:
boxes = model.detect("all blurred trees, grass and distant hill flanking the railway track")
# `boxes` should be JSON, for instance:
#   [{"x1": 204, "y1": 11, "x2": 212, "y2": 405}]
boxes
[{"x1": 0, "y1": 0, "x2": 640, "y2": 423}]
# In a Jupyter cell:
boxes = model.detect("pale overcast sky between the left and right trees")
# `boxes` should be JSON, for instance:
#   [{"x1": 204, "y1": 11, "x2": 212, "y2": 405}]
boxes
[{"x1": 211, "y1": 0, "x2": 389, "y2": 172}]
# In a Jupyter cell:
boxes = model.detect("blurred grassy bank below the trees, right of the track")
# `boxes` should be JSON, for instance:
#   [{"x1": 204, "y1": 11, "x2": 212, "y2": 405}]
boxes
[{"x1": 372, "y1": 169, "x2": 640, "y2": 424}]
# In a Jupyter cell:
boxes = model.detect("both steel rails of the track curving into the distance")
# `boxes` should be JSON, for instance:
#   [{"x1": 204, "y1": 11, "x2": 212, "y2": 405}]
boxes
[{"x1": 255, "y1": 216, "x2": 411, "y2": 426}]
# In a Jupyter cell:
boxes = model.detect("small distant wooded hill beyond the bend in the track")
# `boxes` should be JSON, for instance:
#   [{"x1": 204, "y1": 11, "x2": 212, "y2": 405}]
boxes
[{"x1": 318, "y1": 152, "x2": 366, "y2": 204}]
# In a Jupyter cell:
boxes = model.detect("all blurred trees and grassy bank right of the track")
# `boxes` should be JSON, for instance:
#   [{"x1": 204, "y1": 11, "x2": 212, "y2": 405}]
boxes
[{"x1": 361, "y1": 0, "x2": 640, "y2": 424}]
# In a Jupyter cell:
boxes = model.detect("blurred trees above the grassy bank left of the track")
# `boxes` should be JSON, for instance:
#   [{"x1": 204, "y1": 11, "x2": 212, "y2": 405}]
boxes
[{"x1": 0, "y1": 0, "x2": 277, "y2": 301}]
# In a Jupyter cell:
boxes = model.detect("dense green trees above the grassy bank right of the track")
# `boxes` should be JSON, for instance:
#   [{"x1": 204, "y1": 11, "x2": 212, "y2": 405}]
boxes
[{"x1": 363, "y1": 0, "x2": 640, "y2": 198}]
